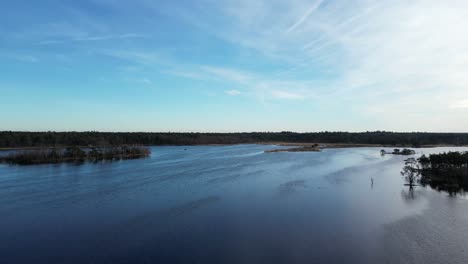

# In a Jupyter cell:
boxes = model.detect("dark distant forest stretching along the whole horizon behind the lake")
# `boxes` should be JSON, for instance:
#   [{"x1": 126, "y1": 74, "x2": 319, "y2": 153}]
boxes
[{"x1": 0, "y1": 131, "x2": 468, "y2": 148}]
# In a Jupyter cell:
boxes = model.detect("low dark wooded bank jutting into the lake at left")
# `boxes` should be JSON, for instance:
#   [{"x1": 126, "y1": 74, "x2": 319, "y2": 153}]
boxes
[{"x1": 0, "y1": 146, "x2": 151, "y2": 165}]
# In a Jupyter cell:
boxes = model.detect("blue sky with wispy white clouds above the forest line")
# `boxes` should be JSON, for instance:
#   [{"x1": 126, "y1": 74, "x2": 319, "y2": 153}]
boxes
[{"x1": 0, "y1": 0, "x2": 468, "y2": 132}]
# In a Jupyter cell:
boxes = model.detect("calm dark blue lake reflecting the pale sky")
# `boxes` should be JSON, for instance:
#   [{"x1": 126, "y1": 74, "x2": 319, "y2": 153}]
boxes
[{"x1": 0, "y1": 145, "x2": 468, "y2": 263}]
